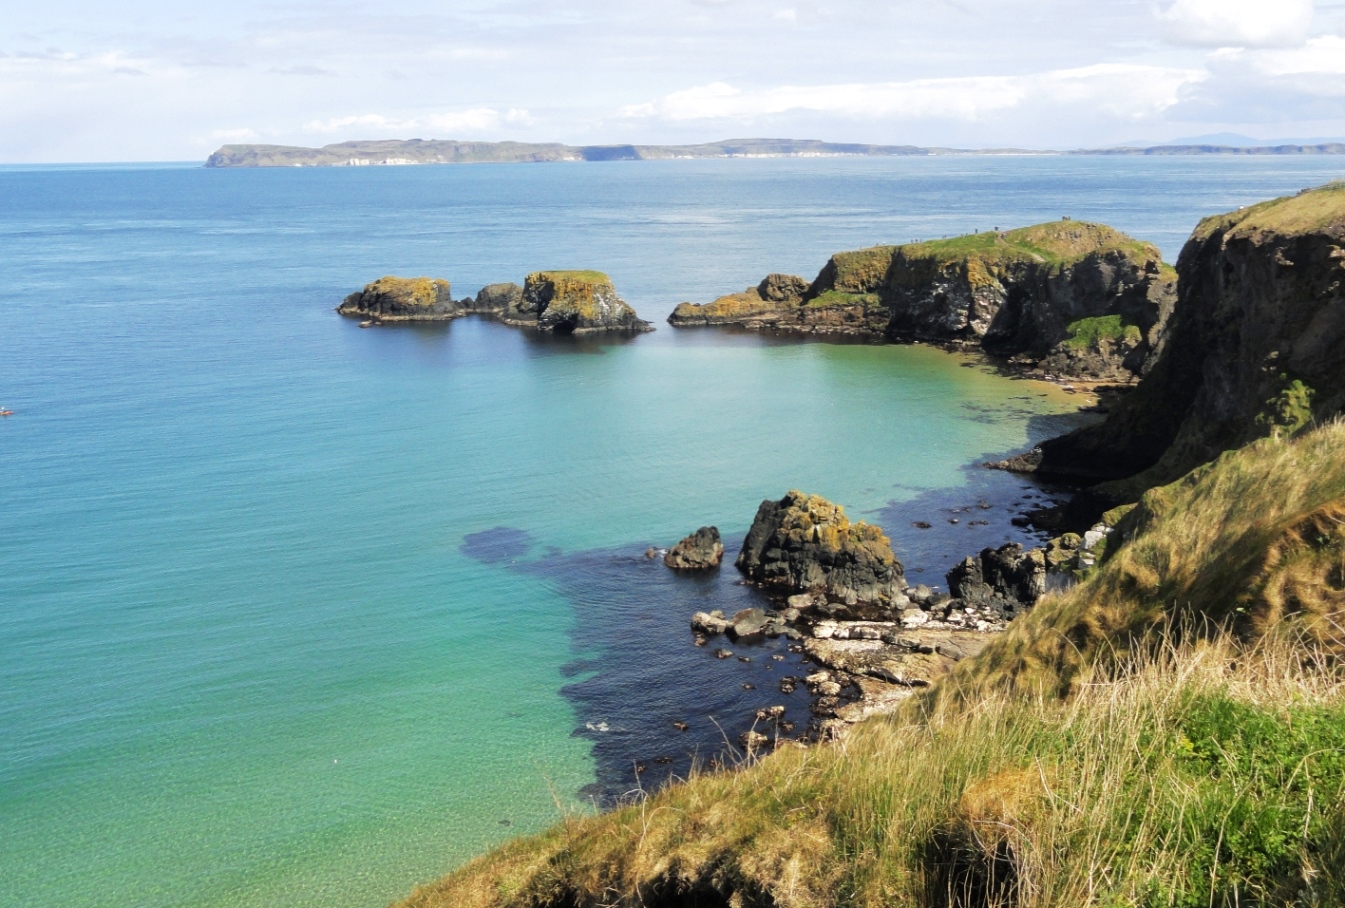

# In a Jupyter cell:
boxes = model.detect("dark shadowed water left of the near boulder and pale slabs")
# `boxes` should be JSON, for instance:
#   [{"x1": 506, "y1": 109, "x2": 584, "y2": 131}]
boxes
[{"x1": 461, "y1": 527, "x2": 811, "y2": 806}]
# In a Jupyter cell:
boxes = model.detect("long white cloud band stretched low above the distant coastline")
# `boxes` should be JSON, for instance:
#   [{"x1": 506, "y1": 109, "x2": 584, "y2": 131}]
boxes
[{"x1": 620, "y1": 63, "x2": 1208, "y2": 121}]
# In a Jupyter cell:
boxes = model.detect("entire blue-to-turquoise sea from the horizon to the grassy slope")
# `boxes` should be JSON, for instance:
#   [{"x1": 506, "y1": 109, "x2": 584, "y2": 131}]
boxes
[{"x1": 0, "y1": 156, "x2": 1345, "y2": 908}]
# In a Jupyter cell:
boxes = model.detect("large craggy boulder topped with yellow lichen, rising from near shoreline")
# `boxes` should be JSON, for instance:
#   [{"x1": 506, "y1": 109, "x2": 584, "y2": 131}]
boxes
[{"x1": 737, "y1": 491, "x2": 907, "y2": 609}]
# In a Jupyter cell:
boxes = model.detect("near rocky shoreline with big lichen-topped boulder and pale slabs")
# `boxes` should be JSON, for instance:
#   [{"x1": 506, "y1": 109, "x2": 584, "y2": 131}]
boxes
[{"x1": 670, "y1": 491, "x2": 1077, "y2": 756}]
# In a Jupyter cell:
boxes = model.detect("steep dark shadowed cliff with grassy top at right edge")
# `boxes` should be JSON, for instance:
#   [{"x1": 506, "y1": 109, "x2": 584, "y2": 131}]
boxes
[{"x1": 1025, "y1": 183, "x2": 1345, "y2": 502}]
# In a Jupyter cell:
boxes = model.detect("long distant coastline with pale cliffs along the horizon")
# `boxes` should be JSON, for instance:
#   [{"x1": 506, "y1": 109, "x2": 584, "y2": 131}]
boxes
[{"x1": 206, "y1": 139, "x2": 1345, "y2": 168}]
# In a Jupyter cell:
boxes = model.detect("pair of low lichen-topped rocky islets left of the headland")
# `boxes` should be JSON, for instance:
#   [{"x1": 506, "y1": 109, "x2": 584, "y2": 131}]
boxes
[{"x1": 336, "y1": 270, "x2": 654, "y2": 334}]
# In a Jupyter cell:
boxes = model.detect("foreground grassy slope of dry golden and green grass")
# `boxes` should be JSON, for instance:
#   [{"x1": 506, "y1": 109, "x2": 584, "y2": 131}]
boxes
[{"x1": 405, "y1": 425, "x2": 1345, "y2": 908}]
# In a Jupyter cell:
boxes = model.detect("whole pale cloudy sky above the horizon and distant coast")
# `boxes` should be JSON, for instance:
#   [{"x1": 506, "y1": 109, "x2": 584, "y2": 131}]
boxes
[{"x1": 0, "y1": 0, "x2": 1345, "y2": 163}]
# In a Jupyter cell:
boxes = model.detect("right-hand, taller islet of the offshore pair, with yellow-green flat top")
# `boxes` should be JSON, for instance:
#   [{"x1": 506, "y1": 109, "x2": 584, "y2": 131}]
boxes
[{"x1": 499, "y1": 270, "x2": 652, "y2": 334}]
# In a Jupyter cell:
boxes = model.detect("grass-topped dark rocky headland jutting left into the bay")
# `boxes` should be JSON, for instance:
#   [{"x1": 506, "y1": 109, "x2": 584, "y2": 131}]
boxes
[{"x1": 668, "y1": 221, "x2": 1176, "y2": 381}]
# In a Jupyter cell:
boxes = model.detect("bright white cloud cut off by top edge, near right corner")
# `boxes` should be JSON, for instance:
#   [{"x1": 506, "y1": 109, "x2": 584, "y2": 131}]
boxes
[{"x1": 1157, "y1": 0, "x2": 1315, "y2": 47}]
